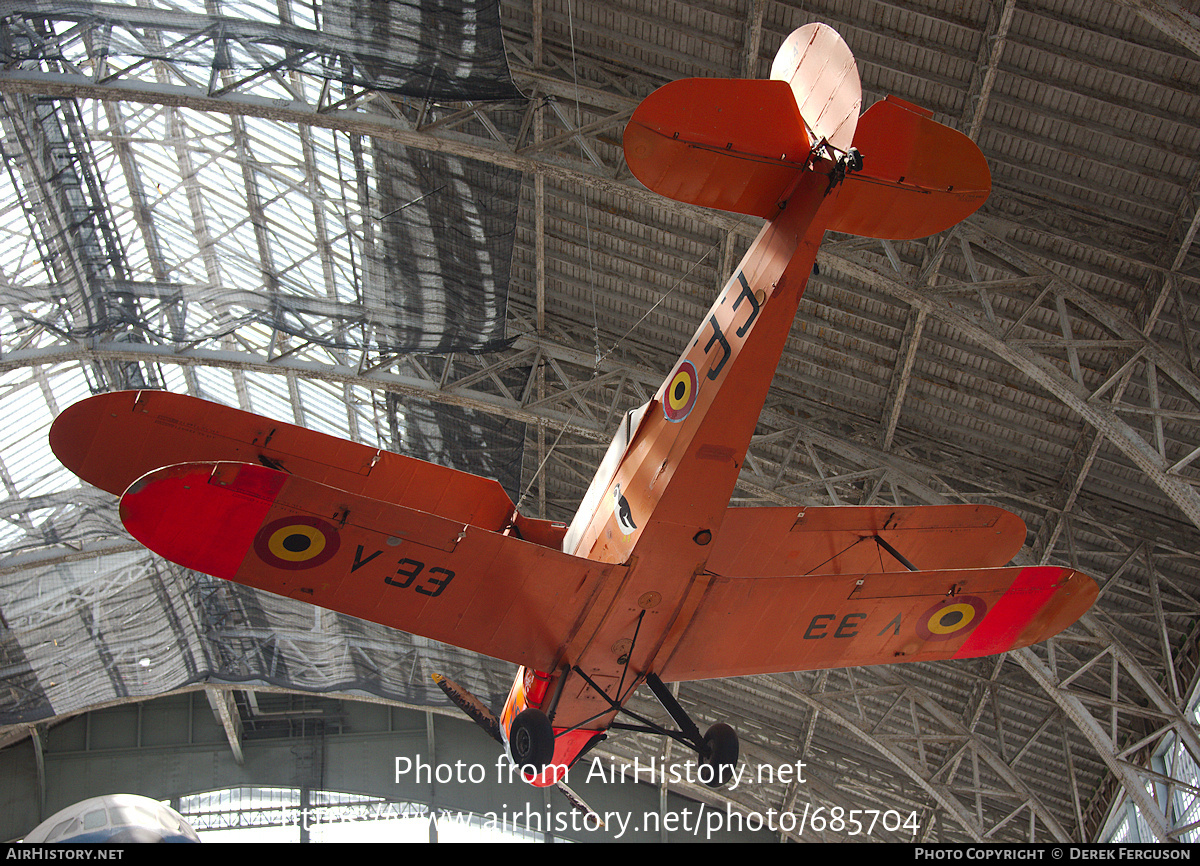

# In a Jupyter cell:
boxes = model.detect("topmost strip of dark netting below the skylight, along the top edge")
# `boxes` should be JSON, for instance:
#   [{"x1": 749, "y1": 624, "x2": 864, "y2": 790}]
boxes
[{"x1": 0, "y1": 0, "x2": 521, "y2": 100}]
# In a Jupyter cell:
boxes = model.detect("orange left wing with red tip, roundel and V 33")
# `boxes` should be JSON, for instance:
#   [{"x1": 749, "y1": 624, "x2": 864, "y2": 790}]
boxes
[{"x1": 121, "y1": 463, "x2": 625, "y2": 670}]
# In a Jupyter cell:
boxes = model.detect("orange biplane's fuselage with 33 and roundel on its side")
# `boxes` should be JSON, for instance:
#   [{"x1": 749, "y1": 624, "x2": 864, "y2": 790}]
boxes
[{"x1": 502, "y1": 161, "x2": 838, "y2": 783}]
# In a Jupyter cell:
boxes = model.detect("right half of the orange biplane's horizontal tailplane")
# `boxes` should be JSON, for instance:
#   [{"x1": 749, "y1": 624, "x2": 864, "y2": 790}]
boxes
[{"x1": 822, "y1": 96, "x2": 991, "y2": 240}]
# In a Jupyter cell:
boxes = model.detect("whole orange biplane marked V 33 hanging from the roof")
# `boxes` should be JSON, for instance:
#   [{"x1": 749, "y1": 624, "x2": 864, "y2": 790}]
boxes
[{"x1": 50, "y1": 24, "x2": 1097, "y2": 801}]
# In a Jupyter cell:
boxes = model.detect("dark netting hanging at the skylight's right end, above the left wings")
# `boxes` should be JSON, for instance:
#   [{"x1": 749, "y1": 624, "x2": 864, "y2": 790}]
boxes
[{"x1": 272, "y1": 139, "x2": 521, "y2": 353}]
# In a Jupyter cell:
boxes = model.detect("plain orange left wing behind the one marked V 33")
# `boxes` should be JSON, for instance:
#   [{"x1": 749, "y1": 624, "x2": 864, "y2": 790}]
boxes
[{"x1": 50, "y1": 391, "x2": 565, "y2": 547}]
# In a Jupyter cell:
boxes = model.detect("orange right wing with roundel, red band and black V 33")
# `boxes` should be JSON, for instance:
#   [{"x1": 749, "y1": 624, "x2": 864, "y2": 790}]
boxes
[{"x1": 659, "y1": 558, "x2": 1097, "y2": 680}]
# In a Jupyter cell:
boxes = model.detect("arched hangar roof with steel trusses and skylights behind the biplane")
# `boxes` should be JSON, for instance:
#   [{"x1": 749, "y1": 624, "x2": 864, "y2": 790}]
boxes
[{"x1": 0, "y1": 0, "x2": 1200, "y2": 841}]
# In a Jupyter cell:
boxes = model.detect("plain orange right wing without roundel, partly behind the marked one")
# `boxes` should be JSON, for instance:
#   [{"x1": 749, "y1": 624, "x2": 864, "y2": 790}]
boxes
[{"x1": 708, "y1": 505, "x2": 1025, "y2": 577}]
